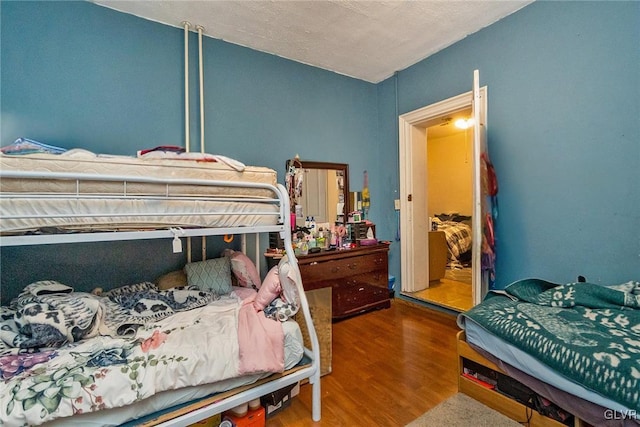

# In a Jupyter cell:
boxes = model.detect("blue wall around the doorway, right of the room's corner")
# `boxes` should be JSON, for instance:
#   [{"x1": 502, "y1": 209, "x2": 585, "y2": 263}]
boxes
[{"x1": 379, "y1": 2, "x2": 640, "y2": 287}]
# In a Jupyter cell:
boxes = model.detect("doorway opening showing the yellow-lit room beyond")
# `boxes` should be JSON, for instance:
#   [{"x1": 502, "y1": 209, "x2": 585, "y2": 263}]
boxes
[{"x1": 403, "y1": 108, "x2": 473, "y2": 312}]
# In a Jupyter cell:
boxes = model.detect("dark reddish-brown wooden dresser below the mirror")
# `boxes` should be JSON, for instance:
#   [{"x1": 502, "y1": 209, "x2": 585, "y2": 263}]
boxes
[{"x1": 298, "y1": 245, "x2": 391, "y2": 320}]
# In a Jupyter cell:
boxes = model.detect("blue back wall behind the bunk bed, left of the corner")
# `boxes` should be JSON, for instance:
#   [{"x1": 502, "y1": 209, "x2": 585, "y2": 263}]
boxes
[{"x1": 0, "y1": 1, "x2": 380, "y2": 301}]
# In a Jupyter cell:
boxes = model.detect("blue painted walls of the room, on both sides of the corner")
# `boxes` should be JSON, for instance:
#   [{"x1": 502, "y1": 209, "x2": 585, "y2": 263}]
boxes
[{"x1": 0, "y1": 1, "x2": 640, "y2": 302}]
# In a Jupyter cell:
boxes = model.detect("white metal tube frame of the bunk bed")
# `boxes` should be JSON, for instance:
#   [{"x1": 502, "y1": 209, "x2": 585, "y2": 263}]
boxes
[{"x1": 0, "y1": 170, "x2": 321, "y2": 426}]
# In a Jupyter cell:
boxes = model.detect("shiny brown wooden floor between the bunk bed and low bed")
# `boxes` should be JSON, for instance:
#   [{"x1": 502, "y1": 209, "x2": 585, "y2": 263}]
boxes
[{"x1": 267, "y1": 298, "x2": 459, "y2": 427}]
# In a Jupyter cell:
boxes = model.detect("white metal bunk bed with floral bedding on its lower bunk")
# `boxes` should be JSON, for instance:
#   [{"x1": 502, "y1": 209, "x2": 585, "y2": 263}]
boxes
[{"x1": 0, "y1": 150, "x2": 320, "y2": 426}]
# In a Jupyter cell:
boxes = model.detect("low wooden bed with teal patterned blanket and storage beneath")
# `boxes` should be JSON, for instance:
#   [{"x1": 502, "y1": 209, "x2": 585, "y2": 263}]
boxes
[{"x1": 457, "y1": 279, "x2": 640, "y2": 427}]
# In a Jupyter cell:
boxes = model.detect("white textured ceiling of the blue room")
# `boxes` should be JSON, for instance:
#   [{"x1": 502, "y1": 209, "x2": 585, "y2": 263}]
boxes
[{"x1": 93, "y1": 0, "x2": 533, "y2": 83}]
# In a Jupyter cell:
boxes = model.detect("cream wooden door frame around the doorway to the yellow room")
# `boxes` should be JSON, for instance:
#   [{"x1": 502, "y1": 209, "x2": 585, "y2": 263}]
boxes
[{"x1": 398, "y1": 86, "x2": 487, "y2": 305}]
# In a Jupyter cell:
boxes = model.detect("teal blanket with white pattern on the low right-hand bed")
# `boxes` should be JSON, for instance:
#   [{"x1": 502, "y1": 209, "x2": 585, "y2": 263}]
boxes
[{"x1": 458, "y1": 279, "x2": 640, "y2": 412}]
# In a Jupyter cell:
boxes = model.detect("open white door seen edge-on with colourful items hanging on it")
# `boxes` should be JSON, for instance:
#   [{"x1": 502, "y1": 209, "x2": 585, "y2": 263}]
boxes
[{"x1": 472, "y1": 70, "x2": 497, "y2": 305}]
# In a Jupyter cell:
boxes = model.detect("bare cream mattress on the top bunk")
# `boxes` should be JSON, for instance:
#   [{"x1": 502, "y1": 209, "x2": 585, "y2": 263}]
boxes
[{"x1": 0, "y1": 149, "x2": 280, "y2": 234}]
